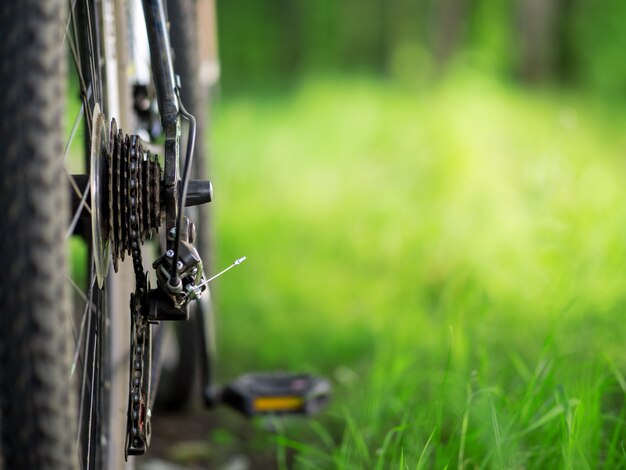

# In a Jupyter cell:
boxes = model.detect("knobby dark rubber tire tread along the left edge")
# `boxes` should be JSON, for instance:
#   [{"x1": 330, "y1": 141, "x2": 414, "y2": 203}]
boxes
[{"x1": 0, "y1": 0, "x2": 77, "y2": 469}]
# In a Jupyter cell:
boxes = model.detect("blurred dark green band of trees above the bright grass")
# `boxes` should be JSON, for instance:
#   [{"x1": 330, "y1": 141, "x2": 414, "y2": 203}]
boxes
[{"x1": 218, "y1": 0, "x2": 626, "y2": 95}]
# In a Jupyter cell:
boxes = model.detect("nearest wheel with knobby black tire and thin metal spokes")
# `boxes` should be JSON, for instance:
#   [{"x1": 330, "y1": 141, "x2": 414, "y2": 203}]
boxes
[{"x1": 0, "y1": 0, "x2": 127, "y2": 469}]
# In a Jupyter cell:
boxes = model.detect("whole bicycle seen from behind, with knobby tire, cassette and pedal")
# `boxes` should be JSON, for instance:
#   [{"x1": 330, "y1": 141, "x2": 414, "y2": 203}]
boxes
[{"x1": 0, "y1": 0, "x2": 329, "y2": 468}]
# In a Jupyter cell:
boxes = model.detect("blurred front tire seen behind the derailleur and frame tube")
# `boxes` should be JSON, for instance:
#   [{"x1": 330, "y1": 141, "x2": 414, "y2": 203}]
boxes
[{"x1": 156, "y1": 0, "x2": 211, "y2": 410}]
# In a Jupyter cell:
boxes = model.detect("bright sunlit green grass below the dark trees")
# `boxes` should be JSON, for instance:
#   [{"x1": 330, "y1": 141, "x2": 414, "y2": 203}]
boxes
[{"x1": 212, "y1": 75, "x2": 626, "y2": 469}]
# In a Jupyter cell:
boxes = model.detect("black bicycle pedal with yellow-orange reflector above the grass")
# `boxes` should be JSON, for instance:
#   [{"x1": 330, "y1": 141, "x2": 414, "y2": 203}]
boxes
[{"x1": 221, "y1": 372, "x2": 330, "y2": 417}]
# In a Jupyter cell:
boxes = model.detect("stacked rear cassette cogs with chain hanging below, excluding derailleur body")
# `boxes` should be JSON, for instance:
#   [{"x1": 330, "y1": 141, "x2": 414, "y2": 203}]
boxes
[{"x1": 105, "y1": 123, "x2": 161, "y2": 456}]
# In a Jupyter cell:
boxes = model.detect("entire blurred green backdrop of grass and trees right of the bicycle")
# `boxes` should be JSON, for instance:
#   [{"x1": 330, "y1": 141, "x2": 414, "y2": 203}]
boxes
[{"x1": 145, "y1": 0, "x2": 626, "y2": 469}]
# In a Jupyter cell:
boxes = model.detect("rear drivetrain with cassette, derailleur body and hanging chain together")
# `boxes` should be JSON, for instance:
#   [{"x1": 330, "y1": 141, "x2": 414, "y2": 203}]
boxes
[{"x1": 79, "y1": 104, "x2": 212, "y2": 456}]
